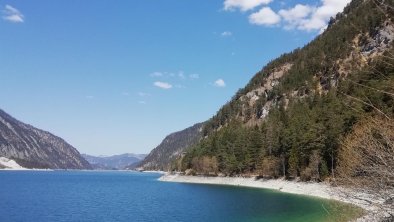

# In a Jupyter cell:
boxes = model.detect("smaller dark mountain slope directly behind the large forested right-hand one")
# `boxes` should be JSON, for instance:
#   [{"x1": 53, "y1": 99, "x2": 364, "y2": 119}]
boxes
[{"x1": 137, "y1": 123, "x2": 203, "y2": 170}]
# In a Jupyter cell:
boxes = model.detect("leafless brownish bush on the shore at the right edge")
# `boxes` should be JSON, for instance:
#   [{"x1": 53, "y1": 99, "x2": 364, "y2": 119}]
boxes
[{"x1": 337, "y1": 117, "x2": 394, "y2": 215}]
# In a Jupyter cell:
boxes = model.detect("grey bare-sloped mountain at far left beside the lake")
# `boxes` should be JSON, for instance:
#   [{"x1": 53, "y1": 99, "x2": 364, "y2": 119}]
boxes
[{"x1": 0, "y1": 109, "x2": 91, "y2": 169}]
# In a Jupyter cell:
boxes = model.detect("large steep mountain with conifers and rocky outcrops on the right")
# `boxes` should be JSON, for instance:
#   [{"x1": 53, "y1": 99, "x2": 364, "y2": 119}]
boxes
[{"x1": 177, "y1": 0, "x2": 394, "y2": 180}]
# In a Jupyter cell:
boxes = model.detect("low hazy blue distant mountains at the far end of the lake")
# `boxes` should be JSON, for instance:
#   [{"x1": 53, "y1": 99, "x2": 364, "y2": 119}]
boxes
[{"x1": 82, "y1": 153, "x2": 147, "y2": 170}]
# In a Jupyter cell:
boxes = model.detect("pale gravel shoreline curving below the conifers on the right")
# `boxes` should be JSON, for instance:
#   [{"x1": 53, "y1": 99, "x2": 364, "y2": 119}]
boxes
[{"x1": 158, "y1": 173, "x2": 387, "y2": 221}]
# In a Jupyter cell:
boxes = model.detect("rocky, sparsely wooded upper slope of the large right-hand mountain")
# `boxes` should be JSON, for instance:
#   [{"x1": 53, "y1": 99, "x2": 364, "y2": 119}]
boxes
[{"x1": 204, "y1": 0, "x2": 394, "y2": 136}]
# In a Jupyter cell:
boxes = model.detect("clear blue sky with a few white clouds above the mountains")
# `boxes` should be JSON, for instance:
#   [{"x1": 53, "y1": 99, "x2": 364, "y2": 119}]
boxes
[{"x1": 0, "y1": 0, "x2": 349, "y2": 155}]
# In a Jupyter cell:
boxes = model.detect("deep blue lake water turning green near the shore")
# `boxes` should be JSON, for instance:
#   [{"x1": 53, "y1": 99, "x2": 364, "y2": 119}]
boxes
[{"x1": 0, "y1": 171, "x2": 358, "y2": 222}]
